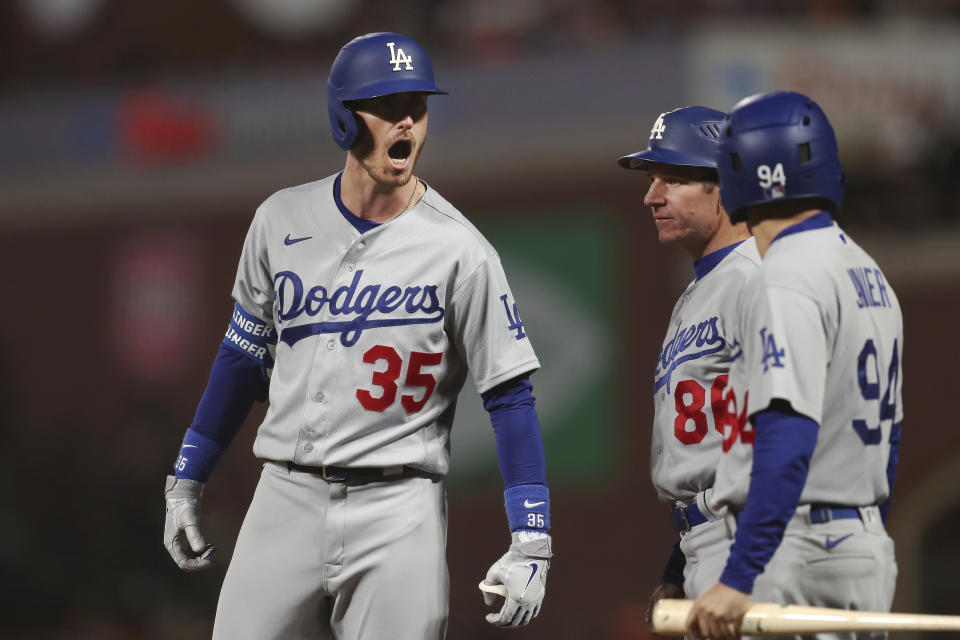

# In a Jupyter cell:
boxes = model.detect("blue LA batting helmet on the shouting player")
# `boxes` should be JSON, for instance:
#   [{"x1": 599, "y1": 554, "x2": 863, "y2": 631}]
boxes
[{"x1": 327, "y1": 33, "x2": 447, "y2": 150}]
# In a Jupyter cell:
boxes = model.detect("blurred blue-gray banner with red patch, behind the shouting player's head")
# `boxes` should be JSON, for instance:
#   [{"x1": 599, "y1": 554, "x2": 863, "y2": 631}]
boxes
[{"x1": 0, "y1": 39, "x2": 684, "y2": 226}]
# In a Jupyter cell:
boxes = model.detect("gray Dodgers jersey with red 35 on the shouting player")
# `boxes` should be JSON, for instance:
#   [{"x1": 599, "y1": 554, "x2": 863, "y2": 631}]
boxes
[{"x1": 233, "y1": 176, "x2": 539, "y2": 474}]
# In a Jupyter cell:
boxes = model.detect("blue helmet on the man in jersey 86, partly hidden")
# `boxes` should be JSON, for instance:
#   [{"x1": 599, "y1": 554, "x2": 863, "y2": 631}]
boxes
[{"x1": 617, "y1": 107, "x2": 727, "y2": 169}]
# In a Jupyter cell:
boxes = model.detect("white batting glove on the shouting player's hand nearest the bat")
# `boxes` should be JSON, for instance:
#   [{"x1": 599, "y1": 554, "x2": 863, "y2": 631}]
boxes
[{"x1": 483, "y1": 531, "x2": 553, "y2": 627}]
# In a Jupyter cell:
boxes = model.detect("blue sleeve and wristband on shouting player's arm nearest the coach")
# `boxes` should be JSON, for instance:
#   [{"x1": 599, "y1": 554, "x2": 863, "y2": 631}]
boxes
[{"x1": 481, "y1": 374, "x2": 550, "y2": 531}]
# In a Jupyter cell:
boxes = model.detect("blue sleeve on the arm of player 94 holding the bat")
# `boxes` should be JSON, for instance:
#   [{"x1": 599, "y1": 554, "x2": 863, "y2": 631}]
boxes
[{"x1": 720, "y1": 403, "x2": 819, "y2": 593}]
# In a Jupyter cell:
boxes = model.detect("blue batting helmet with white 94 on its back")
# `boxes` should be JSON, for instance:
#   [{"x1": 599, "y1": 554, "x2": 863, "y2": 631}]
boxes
[{"x1": 717, "y1": 91, "x2": 844, "y2": 222}]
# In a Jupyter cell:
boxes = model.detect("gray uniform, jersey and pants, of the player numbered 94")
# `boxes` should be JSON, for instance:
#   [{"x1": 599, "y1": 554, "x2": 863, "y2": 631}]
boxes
[{"x1": 712, "y1": 218, "x2": 903, "y2": 640}]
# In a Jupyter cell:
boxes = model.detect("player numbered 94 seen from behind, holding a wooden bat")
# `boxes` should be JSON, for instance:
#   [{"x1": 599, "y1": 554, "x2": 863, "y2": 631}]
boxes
[{"x1": 687, "y1": 92, "x2": 903, "y2": 639}]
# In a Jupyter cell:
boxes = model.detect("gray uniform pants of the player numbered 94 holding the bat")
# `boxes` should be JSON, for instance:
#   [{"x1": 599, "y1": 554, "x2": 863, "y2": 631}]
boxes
[{"x1": 712, "y1": 505, "x2": 897, "y2": 640}]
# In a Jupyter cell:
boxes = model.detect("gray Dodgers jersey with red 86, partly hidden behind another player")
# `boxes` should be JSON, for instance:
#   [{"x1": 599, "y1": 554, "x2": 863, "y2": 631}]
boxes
[{"x1": 650, "y1": 238, "x2": 760, "y2": 504}]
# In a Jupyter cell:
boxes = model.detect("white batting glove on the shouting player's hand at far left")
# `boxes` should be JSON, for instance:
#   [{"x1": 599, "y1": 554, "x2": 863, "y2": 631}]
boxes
[{"x1": 163, "y1": 476, "x2": 215, "y2": 571}]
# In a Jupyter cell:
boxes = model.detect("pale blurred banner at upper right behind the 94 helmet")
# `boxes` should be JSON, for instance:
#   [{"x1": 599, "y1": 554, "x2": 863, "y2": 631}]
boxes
[{"x1": 688, "y1": 22, "x2": 960, "y2": 171}]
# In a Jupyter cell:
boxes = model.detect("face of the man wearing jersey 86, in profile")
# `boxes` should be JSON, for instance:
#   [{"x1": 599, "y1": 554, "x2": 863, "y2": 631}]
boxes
[{"x1": 643, "y1": 164, "x2": 726, "y2": 259}]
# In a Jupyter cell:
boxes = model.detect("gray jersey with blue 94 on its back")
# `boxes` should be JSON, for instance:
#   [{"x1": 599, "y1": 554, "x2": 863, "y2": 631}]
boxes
[{"x1": 713, "y1": 218, "x2": 903, "y2": 510}]
